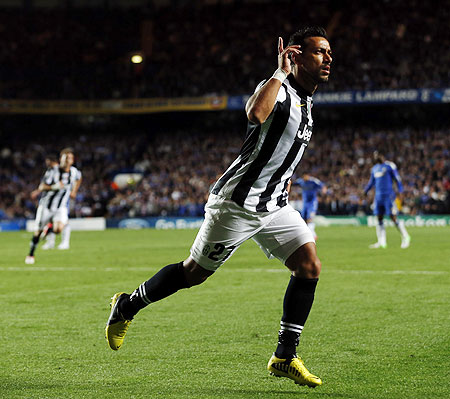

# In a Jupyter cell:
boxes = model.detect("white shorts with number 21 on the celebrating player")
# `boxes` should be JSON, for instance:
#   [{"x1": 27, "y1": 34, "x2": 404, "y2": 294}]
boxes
[{"x1": 191, "y1": 194, "x2": 315, "y2": 271}]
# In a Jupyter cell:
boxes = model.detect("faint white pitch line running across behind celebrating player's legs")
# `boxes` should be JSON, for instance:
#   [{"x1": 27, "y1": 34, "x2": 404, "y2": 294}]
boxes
[{"x1": 0, "y1": 266, "x2": 450, "y2": 276}]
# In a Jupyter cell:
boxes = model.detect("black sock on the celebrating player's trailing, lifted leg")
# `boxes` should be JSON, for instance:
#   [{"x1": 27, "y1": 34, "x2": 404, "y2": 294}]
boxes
[{"x1": 119, "y1": 262, "x2": 189, "y2": 320}]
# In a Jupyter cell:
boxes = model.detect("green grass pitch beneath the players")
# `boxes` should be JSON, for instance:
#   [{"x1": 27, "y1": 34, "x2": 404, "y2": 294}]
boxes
[{"x1": 0, "y1": 227, "x2": 450, "y2": 399}]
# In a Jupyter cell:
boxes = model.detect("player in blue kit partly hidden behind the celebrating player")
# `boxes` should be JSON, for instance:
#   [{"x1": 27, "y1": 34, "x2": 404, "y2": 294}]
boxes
[{"x1": 292, "y1": 174, "x2": 327, "y2": 240}]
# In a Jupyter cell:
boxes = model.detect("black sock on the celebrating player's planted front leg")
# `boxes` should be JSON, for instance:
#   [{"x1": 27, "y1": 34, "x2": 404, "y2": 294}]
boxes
[{"x1": 275, "y1": 276, "x2": 319, "y2": 359}]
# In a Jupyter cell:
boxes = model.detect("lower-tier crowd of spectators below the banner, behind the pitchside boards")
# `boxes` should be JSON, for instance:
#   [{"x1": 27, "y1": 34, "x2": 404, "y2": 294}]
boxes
[{"x1": 0, "y1": 123, "x2": 450, "y2": 219}]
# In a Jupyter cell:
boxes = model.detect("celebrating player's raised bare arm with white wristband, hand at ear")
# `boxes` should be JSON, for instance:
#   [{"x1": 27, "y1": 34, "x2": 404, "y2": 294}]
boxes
[{"x1": 245, "y1": 37, "x2": 301, "y2": 125}]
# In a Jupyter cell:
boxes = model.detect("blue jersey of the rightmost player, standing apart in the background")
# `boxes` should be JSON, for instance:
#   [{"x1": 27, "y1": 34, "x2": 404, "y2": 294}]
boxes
[{"x1": 364, "y1": 161, "x2": 403, "y2": 198}]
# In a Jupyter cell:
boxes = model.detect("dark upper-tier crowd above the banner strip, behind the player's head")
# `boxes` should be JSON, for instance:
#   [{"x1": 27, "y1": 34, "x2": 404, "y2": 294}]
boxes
[{"x1": 0, "y1": 0, "x2": 450, "y2": 99}]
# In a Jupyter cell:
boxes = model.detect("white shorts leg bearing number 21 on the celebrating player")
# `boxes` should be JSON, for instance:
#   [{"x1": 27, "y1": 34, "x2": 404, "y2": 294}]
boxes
[{"x1": 191, "y1": 197, "x2": 263, "y2": 271}]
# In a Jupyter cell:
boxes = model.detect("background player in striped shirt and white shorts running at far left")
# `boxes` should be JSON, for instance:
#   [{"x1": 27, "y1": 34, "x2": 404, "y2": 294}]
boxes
[{"x1": 25, "y1": 148, "x2": 81, "y2": 264}]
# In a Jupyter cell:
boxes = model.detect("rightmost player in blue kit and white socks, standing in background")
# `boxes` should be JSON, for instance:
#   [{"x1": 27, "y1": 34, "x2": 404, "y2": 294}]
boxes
[{"x1": 364, "y1": 151, "x2": 411, "y2": 248}]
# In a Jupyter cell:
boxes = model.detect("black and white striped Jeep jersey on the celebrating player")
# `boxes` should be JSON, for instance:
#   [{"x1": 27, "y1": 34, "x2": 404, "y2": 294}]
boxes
[{"x1": 211, "y1": 75, "x2": 313, "y2": 212}]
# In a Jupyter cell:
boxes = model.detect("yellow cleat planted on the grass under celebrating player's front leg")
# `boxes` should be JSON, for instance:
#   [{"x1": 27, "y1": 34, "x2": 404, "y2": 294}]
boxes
[{"x1": 267, "y1": 355, "x2": 322, "y2": 388}]
